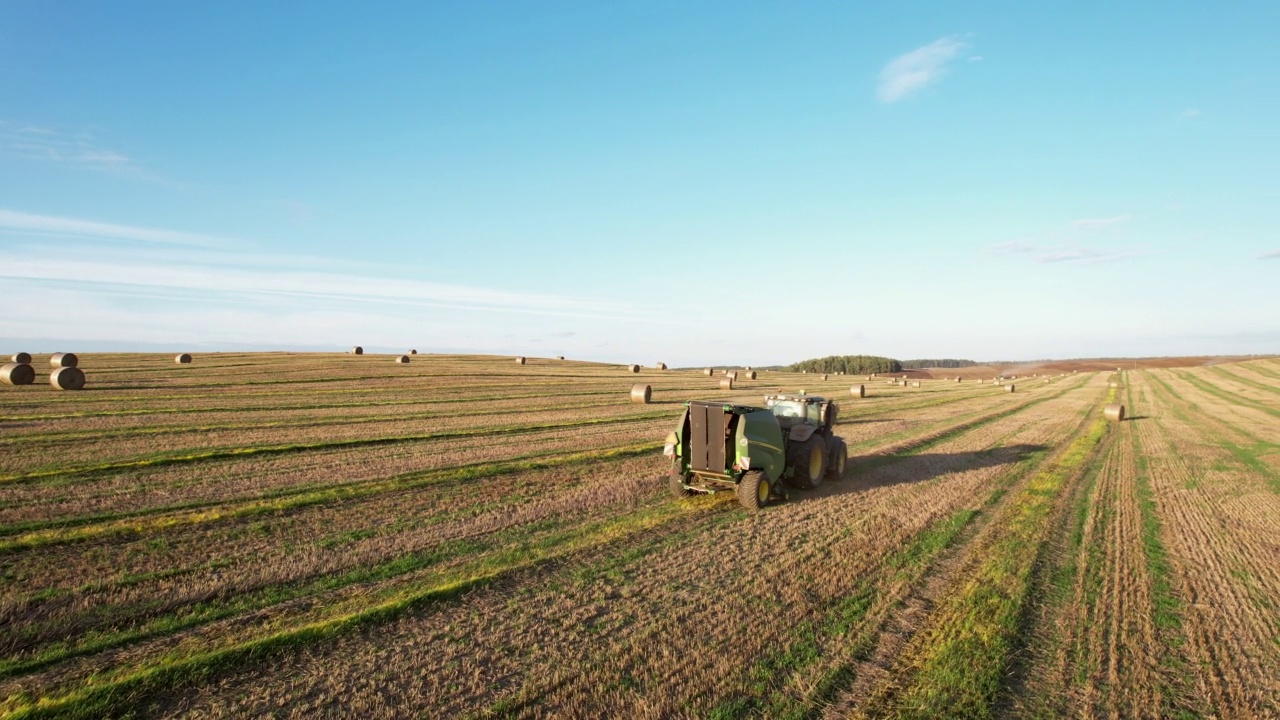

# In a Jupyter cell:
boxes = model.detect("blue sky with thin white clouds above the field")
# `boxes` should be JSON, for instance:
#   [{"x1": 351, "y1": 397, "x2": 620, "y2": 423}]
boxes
[{"x1": 0, "y1": 1, "x2": 1280, "y2": 365}]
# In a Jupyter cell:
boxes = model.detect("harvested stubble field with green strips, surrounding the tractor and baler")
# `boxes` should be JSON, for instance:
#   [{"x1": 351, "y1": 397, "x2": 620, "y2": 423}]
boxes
[{"x1": 0, "y1": 354, "x2": 1280, "y2": 719}]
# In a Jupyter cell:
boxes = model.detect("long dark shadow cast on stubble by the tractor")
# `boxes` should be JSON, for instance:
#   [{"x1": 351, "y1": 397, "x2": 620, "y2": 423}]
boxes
[{"x1": 791, "y1": 445, "x2": 1048, "y2": 502}]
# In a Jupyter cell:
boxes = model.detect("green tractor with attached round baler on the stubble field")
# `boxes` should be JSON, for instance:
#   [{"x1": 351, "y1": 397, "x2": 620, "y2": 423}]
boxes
[{"x1": 663, "y1": 393, "x2": 849, "y2": 510}]
